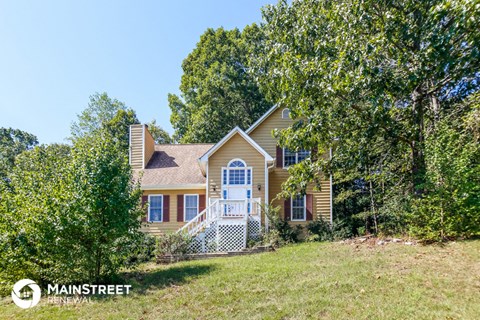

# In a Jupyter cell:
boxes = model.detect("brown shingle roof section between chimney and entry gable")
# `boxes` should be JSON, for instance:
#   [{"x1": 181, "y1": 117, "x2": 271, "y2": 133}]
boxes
[{"x1": 142, "y1": 144, "x2": 213, "y2": 188}]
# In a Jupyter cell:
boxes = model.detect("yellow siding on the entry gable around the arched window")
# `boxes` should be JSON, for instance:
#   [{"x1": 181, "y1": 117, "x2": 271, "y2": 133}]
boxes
[{"x1": 208, "y1": 133, "x2": 265, "y2": 201}]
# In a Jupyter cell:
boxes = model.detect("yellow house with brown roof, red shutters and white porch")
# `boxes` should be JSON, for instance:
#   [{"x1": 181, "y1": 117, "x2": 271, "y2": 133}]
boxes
[{"x1": 129, "y1": 106, "x2": 332, "y2": 252}]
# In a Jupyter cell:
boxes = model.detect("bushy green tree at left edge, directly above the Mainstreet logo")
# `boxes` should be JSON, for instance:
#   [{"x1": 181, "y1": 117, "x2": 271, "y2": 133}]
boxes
[{"x1": 0, "y1": 145, "x2": 72, "y2": 283}]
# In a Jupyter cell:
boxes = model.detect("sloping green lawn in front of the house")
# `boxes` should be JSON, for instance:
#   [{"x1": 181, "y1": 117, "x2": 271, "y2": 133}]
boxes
[{"x1": 0, "y1": 241, "x2": 480, "y2": 319}]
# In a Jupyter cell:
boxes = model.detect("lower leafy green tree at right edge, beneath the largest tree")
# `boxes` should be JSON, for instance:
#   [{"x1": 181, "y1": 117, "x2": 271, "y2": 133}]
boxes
[{"x1": 410, "y1": 93, "x2": 480, "y2": 240}]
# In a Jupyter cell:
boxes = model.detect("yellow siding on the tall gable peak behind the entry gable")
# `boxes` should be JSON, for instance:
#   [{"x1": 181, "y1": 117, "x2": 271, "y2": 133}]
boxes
[{"x1": 249, "y1": 108, "x2": 293, "y2": 158}]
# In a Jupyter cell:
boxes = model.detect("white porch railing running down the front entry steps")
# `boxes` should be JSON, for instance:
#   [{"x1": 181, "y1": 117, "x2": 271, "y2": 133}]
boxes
[{"x1": 177, "y1": 198, "x2": 261, "y2": 236}]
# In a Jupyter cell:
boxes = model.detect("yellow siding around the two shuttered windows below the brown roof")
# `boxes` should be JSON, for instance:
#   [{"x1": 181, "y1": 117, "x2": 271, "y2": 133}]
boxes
[{"x1": 140, "y1": 189, "x2": 205, "y2": 235}]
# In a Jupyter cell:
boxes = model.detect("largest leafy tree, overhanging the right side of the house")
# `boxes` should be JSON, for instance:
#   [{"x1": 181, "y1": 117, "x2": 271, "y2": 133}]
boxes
[{"x1": 251, "y1": 0, "x2": 480, "y2": 236}]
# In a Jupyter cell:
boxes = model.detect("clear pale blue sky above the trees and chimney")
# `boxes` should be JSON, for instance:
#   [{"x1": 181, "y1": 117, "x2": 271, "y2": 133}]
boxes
[{"x1": 0, "y1": 0, "x2": 276, "y2": 143}]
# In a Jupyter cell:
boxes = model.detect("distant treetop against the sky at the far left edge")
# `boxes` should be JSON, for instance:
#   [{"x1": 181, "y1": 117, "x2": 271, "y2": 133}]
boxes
[{"x1": 0, "y1": 128, "x2": 38, "y2": 179}]
